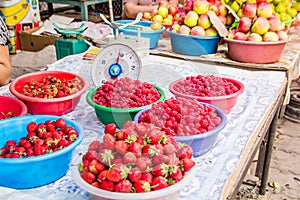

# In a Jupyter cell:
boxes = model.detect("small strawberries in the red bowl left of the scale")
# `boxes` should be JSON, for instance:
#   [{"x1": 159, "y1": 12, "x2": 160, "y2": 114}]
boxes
[{"x1": 21, "y1": 76, "x2": 83, "y2": 99}]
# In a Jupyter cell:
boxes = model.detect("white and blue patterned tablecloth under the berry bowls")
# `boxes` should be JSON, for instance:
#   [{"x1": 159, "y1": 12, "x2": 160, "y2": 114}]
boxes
[{"x1": 0, "y1": 54, "x2": 285, "y2": 200}]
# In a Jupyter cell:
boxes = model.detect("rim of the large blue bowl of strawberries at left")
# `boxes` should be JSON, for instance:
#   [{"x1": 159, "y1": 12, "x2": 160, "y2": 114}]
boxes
[{"x1": 0, "y1": 115, "x2": 84, "y2": 164}]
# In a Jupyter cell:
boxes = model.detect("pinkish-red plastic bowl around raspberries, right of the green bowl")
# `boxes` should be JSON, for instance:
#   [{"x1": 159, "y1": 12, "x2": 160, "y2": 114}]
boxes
[{"x1": 169, "y1": 78, "x2": 245, "y2": 114}]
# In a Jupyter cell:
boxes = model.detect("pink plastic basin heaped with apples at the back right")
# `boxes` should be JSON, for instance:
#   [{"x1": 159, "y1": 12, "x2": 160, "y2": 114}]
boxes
[{"x1": 224, "y1": 38, "x2": 287, "y2": 64}]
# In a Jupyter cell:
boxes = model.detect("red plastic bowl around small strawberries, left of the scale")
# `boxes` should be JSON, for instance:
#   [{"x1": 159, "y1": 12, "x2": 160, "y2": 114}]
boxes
[{"x1": 9, "y1": 71, "x2": 87, "y2": 115}]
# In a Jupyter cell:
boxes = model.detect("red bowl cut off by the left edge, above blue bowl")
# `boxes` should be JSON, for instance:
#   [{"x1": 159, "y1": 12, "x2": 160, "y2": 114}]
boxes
[{"x1": 0, "y1": 96, "x2": 27, "y2": 117}]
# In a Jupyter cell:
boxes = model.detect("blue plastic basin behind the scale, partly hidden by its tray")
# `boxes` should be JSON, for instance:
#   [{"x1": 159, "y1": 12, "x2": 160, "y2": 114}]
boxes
[{"x1": 112, "y1": 20, "x2": 165, "y2": 49}]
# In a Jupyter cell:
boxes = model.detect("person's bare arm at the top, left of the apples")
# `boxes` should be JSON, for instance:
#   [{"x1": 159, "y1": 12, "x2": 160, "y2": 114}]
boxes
[{"x1": 124, "y1": 2, "x2": 158, "y2": 19}]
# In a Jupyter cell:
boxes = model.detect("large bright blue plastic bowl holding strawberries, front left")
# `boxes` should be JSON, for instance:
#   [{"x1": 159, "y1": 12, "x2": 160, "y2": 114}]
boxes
[{"x1": 0, "y1": 115, "x2": 83, "y2": 189}]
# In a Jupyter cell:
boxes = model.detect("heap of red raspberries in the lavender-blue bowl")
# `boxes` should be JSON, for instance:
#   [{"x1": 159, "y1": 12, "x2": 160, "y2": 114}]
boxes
[{"x1": 138, "y1": 97, "x2": 222, "y2": 136}]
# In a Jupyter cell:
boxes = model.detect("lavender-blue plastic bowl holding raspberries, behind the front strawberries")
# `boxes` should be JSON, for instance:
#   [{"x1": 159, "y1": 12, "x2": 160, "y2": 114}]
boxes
[{"x1": 134, "y1": 102, "x2": 227, "y2": 157}]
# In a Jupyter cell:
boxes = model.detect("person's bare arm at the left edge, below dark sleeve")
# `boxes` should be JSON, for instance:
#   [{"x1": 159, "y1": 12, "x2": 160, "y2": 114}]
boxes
[{"x1": 0, "y1": 45, "x2": 12, "y2": 86}]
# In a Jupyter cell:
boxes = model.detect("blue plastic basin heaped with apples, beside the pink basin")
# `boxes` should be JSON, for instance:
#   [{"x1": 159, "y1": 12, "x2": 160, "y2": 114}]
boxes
[{"x1": 167, "y1": 30, "x2": 220, "y2": 56}]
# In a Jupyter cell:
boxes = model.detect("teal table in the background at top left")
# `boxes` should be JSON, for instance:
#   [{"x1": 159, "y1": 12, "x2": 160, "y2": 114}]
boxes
[{"x1": 40, "y1": 0, "x2": 108, "y2": 21}]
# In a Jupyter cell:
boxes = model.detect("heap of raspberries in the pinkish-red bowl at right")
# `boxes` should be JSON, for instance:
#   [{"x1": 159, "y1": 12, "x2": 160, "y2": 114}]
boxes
[{"x1": 174, "y1": 75, "x2": 239, "y2": 97}]
